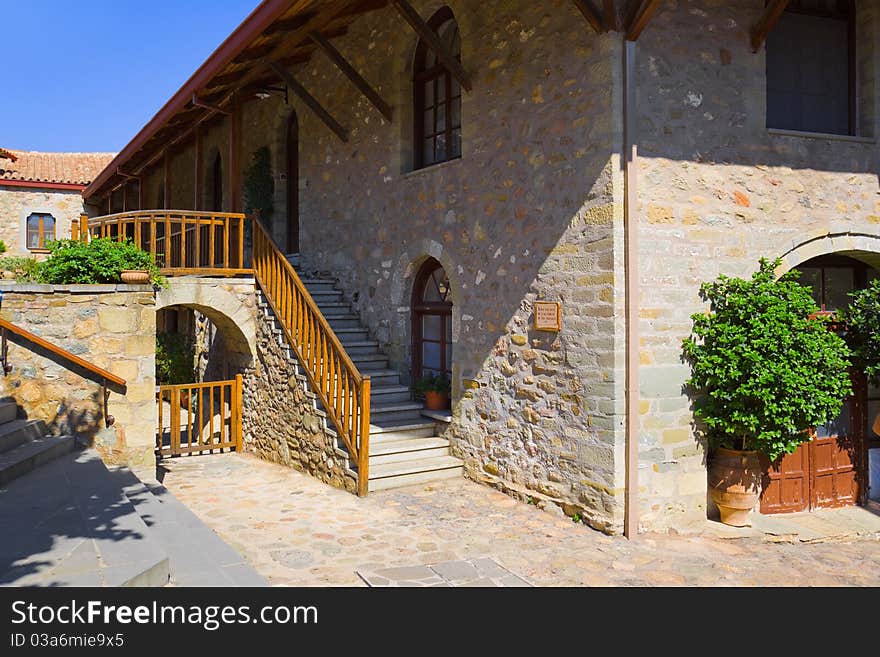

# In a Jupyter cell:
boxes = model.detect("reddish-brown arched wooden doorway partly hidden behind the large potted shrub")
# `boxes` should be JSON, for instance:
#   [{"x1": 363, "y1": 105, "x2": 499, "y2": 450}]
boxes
[{"x1": 761, "y1": 254, "x2": 880, "y2": 513}]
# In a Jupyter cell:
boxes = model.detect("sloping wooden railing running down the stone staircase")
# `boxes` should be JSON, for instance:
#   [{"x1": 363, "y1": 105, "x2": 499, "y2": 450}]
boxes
[{"x1": 254, "y1": 222, "x2": 370, "y2": 496}]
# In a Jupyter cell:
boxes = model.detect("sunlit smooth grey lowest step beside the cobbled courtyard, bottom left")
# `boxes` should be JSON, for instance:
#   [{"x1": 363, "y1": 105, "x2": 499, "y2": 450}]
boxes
[{"x1": 110, "y1": 467, "x2": 269, "y2": 587}]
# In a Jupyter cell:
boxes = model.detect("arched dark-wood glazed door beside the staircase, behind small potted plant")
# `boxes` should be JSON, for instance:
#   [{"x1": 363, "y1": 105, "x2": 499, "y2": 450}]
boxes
[{"x1": 412, "y1": 258, "x2": 452, "y2": 379}]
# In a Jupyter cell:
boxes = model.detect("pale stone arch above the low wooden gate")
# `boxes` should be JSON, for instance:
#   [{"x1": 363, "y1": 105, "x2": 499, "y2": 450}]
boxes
[{"x1": 156, "y1": 278, "x2": 257, "y2": 367}]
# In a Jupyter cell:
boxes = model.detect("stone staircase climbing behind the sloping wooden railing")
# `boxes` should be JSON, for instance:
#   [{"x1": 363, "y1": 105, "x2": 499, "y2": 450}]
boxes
[{"x1": 258, "y1": 256, "x2": 464, "y2": 491}]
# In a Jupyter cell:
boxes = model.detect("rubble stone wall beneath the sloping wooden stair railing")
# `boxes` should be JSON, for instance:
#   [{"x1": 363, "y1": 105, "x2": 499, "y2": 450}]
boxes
[{"x1": 242, "y1": 302, "x2": 357, "y2": 493}]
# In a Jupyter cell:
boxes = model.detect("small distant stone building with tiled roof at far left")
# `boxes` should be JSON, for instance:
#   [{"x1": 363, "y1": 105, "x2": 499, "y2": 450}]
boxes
[{"x1": 0, "y1": 148, "x2": 115, "y2": 256}]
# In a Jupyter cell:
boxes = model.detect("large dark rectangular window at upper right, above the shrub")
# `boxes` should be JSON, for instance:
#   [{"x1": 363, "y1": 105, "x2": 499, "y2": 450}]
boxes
[{"x1": 767, "y1": 0, "x2": 856, "y2": 135}]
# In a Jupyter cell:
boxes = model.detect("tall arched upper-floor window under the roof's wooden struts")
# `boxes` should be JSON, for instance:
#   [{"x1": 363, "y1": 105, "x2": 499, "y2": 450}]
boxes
[{"x1": 413, "y1": 7, "x2": 461, "y2": 169}]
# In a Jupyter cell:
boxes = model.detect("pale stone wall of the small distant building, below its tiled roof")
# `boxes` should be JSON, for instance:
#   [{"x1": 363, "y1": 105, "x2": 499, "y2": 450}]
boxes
[{"x1": 0, "y1": 185, "x2": 83, "y2": 256}]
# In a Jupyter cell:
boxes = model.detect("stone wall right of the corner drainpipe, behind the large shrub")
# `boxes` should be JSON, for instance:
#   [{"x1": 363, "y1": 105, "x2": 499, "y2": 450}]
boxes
[{"x1": 637, "y1": 0, "x2": 880, "y2": 528}]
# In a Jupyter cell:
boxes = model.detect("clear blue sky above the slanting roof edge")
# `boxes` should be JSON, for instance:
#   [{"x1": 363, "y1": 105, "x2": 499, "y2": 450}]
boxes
[{"x1": 0, "y1": 0, "x2": 259, "y2": 151}]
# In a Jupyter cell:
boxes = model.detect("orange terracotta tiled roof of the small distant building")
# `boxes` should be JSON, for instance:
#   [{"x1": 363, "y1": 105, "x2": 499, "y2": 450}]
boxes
[{"x1": 0, "y1": 149, "x2": 116, "y2": 185}]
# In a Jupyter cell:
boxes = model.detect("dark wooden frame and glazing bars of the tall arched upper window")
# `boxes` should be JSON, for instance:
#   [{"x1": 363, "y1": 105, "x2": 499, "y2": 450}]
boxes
[{"x1": 413, "y1": 7, "x2": 462, "y2": 170}]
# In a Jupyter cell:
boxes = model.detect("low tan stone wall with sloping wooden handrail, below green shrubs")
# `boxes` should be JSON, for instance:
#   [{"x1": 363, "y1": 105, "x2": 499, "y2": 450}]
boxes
[{"x1": 0, "y1": 283, "x2": 157, "y2": 477}]
